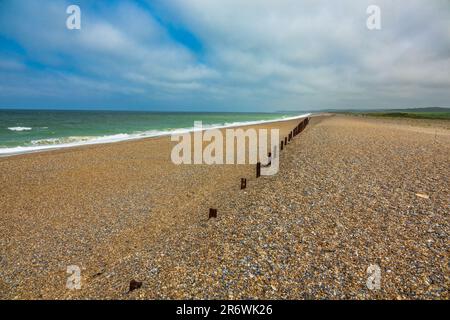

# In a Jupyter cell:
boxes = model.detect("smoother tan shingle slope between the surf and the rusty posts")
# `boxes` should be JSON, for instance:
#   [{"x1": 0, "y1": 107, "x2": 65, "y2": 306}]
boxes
[{"x1": 0, "y1": 114, "x2": 306, "y2": 299}]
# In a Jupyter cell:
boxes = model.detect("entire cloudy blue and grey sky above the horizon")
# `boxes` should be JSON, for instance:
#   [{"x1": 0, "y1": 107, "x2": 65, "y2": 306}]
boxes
[{"x1": 0, "y1": 0, "x2": 450, "y2": 112}]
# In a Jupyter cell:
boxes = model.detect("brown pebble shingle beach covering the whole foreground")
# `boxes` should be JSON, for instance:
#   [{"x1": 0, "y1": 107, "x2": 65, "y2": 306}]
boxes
[{"x1": 0, "y1": 116, "x2": 450, "y2": 299}]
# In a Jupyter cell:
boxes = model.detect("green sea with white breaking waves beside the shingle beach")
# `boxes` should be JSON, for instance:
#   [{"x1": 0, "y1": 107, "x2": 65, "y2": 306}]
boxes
[{"x1": 0, "y1": 110, "x2": 310, "y2": 156}]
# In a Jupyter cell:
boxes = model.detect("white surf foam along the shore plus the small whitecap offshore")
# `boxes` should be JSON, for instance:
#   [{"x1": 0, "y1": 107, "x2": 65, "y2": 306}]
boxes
[{"x1": 0, "y1": 113, "x2": 311, "y2": 156}]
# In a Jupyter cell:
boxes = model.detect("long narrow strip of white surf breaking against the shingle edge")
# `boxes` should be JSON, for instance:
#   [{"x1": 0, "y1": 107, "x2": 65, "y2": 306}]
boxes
[{"x1": 0, "y1": 113, "x2": 313, "y2": 159}]
